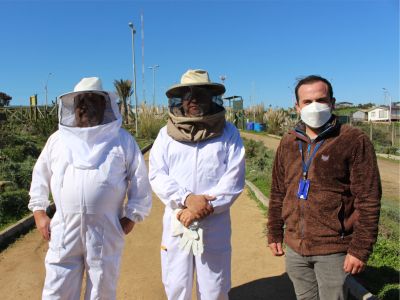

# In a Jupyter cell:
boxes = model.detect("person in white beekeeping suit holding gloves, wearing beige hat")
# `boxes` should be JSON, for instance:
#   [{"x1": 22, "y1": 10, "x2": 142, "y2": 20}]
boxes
[{"x1": 149, "y1": 70, "x2": 245, "y2": 300}]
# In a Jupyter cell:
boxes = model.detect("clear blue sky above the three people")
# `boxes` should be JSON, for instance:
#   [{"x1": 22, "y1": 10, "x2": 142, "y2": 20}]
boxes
[{"x1": 0, "y1": 0, "x2": 399, "y2": 108}]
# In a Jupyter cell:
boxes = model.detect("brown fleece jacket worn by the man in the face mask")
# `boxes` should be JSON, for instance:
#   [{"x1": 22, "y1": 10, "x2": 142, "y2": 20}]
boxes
[{"x1": 267, "y1": 115, "x2": 382, "y2": 262}]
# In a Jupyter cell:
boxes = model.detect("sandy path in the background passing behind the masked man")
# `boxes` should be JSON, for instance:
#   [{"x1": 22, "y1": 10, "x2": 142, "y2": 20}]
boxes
[{"x1": 240, "y1": 132, "x2": 400, "y2": 204}]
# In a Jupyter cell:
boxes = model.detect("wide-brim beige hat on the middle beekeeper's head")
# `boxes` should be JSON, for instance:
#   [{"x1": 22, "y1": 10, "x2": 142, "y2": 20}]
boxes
[{"x1": 166, "y1": 70, "x2": 225, "y2": 98}]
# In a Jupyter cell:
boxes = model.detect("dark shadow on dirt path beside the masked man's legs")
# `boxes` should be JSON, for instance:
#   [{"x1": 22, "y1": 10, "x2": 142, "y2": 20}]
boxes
[{"x1": 229, "y1": 273, "x2": 296, "y2": 300}]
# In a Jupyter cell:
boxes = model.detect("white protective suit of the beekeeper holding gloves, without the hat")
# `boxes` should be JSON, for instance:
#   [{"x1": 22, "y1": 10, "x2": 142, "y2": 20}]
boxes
[{"x1": 149, "y1": 122, "x2": 245, "y2": 300}]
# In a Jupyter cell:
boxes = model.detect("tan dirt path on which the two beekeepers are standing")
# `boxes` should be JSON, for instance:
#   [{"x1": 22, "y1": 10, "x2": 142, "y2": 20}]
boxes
[{"x1": 0, "y1": 153, "x2": 295, "y2": 300}]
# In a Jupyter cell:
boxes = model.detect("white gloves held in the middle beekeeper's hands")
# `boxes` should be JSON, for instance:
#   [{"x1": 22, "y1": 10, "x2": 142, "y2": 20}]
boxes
[{"x1": 179, "y1": 221, "x2": 204, "y2": 255}]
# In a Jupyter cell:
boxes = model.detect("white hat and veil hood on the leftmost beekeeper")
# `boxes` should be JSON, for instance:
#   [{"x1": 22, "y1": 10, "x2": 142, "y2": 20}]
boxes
[{"x1": 58, "y1": 77, "x2": 122, "y2": 169}]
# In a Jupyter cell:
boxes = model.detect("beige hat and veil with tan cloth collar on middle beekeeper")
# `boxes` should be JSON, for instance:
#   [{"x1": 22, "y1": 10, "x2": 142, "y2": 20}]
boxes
[{"x1": 166, "y1": 70, "x2": 226, "y2": 142}]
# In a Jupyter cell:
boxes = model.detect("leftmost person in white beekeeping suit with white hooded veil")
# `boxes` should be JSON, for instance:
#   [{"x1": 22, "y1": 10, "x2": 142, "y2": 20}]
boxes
[{"x1": 29, "y1": 77, "x2": 152, "y2": 300}]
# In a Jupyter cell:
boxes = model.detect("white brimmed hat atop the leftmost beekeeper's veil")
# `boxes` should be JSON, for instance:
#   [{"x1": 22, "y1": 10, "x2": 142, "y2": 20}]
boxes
[{"x1": 58, "y1": 77, "x2": 118, "y2": 104}]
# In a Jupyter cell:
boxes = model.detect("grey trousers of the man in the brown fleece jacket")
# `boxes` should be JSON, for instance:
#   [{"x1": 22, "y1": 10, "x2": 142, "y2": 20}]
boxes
[{"x1": 285, "y1": 247, "x2": 350, "y2": 300}]
